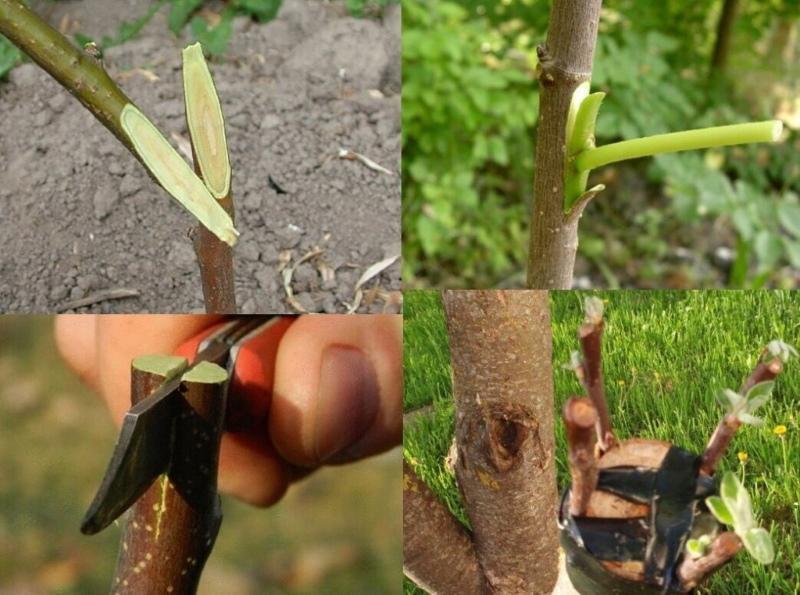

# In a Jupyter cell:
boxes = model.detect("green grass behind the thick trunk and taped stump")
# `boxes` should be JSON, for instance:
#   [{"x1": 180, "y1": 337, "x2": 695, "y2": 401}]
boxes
[{"x1": 404, "y1": 291, "x2": 800, "y2": 595}]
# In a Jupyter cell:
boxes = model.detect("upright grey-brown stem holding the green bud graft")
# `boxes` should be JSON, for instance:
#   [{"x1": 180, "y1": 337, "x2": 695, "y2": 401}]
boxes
[{"x1": 528, "y1": 0, "x2": 601, "y2": 289}]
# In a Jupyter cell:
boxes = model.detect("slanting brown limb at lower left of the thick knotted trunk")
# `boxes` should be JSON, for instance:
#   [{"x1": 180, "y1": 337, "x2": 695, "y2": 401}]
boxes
[{"x1": 403, "y1": 461, "x2": 488, "y2": 595}]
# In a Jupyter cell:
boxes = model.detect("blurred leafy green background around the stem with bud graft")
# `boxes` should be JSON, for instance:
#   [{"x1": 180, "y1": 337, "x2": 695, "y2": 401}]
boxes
[{"x1": 403, "y1": 0, "x2": 800, "y2": 288}]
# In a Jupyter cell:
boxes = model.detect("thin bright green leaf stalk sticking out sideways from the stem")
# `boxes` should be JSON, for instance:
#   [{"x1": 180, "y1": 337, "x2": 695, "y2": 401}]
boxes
[{"x1": 575, "y1": 120, "x2": 783, "y2": 171}]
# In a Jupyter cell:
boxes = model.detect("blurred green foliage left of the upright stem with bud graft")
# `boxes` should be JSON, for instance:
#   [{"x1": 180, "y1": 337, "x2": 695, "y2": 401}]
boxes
[{"x1": 403, "y1": 0, "x2": 538, "y2": 285}]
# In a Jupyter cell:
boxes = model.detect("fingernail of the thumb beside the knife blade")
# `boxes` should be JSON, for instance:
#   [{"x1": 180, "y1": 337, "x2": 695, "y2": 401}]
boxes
[{"x1": 315, "y1": 345, "x2": 379, "y2": 463}]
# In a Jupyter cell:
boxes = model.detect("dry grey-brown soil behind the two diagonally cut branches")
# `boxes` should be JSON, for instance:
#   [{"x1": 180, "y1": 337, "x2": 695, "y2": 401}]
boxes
[{"x1": 0, "y1": 0, "x2": 401, "y2": 313}]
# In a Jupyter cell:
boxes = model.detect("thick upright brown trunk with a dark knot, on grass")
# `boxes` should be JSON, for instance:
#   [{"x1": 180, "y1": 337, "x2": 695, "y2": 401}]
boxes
[{"x1": 444, "y1": 291, "x2": 558, "y2": 594}]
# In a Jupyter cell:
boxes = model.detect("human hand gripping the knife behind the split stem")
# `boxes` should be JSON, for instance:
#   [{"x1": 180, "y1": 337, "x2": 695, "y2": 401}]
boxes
[{"x1": 55, "y1": 315, "x2": 403, "y2": 506}]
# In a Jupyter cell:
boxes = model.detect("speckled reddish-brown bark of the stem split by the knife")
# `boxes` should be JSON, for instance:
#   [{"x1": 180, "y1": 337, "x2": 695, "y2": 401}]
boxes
[{"x1": 112, "y1": 368, "x2": 225, "y2": 594}]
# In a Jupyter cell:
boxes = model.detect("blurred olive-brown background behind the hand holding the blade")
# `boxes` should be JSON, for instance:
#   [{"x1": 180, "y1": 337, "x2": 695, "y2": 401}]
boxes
[{"x1": 0, "y1": 316, "x2": 402, "y2": 595}]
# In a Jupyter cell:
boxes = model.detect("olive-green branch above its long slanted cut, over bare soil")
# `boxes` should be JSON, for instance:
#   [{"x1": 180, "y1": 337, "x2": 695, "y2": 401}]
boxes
[{"x1": 0, "y1": 0, "x2": 138, "y2": 151}]
